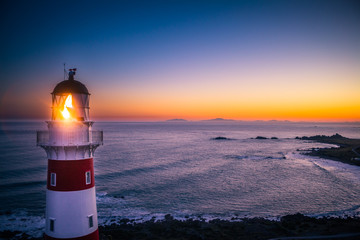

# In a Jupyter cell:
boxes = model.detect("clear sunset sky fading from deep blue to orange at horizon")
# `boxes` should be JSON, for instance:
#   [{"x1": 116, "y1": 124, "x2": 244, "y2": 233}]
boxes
[{"x1": 0, "y1": 0, "x2": 360, "y2": 121}]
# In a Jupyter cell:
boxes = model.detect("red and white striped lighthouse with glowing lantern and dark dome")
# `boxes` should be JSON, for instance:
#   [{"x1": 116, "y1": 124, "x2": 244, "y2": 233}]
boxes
[{"x1": 37, "y1": 69, "x2": 103, "y2": 240}]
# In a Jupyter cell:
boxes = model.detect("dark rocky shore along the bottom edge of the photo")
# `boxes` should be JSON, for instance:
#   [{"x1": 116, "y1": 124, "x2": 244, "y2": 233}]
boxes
[{"x1": 0, "y1": 214, "x2": 360, "y2": 240}]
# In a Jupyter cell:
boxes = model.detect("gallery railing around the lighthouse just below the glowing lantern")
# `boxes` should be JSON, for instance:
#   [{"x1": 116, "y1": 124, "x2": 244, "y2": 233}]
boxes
[{"x1": 36, "y1": 131, "x2": 103, "y2": 146}]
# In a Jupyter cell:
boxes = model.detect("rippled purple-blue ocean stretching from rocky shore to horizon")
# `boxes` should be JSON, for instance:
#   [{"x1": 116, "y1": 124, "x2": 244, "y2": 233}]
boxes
[{"x1": 0, "y1": 121, "x2": 360, "y2": 237}]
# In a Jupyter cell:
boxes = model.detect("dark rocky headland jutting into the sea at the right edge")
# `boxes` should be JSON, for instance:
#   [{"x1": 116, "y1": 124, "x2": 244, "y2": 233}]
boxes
[{"x1": 296, "y1": 134, "x2": 360, "y2": 166}]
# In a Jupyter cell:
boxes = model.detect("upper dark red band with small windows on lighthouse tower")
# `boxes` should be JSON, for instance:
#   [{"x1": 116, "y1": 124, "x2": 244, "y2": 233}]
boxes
[{"x1": 47, "y1": 158, "x2": 95, "y2": 191}]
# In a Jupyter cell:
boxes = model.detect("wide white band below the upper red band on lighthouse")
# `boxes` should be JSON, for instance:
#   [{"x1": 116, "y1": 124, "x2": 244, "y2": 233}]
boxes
[{"x1": 45, "y1": 187, "x2": 98, "y2": 238}]
